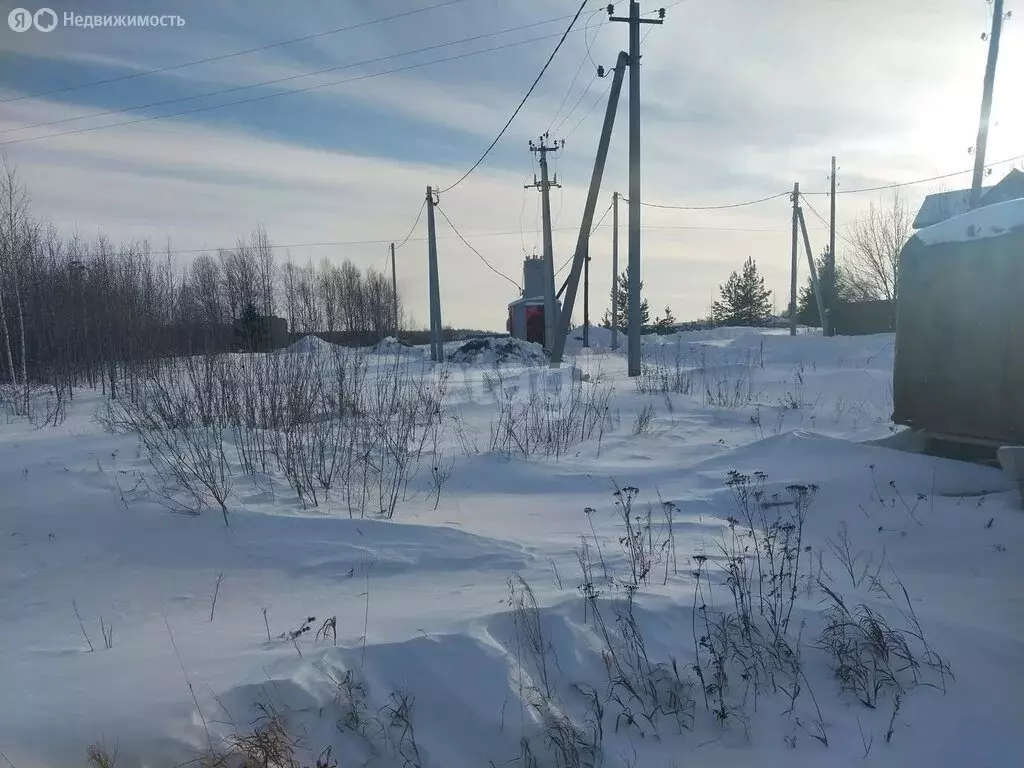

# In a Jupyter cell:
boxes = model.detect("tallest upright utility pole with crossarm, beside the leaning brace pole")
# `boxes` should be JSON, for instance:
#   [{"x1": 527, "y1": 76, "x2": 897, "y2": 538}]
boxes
[{"x1": 608, "y1": 0, "x2": 665, "y2": 377}]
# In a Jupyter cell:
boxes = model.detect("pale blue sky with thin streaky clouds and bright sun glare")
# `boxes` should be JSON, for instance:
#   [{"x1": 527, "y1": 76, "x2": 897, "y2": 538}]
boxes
[{"x1": 0, "y1": 0, "x2": 1024, "y2": 329}]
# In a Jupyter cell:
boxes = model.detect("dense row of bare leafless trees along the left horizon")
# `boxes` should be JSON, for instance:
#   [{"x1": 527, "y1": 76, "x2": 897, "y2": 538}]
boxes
[{"x1": 0, "y1": 162, "x2": 404, "y2": 400}]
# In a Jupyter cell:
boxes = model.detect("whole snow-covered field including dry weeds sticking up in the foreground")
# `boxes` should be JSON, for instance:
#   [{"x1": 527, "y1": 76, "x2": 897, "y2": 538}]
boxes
[{"x1": 0, "y1": 329, "x2": 1024, "y2": 768}]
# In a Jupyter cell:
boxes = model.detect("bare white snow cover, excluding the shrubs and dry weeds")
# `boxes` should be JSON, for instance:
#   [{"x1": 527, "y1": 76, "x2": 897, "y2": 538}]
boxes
[{"x1": 0, "y1": 329, "x2": 1024, "y2": 768}]
